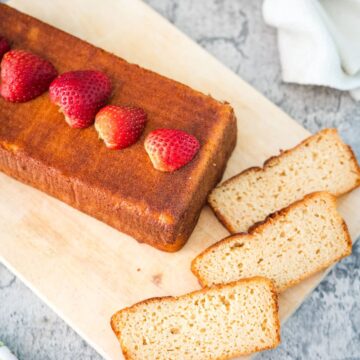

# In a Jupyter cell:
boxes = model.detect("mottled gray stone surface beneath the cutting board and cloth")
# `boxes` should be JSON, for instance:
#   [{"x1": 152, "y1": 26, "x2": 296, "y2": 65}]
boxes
[{"x1": 0, "y1": 0, "x2": 360, "y2": 360}]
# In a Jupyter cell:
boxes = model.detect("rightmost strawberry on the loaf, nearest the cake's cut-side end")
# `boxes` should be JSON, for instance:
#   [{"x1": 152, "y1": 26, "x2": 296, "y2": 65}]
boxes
[{"x1": 145, "y1": 129, "x2": 200, "y2": 171}]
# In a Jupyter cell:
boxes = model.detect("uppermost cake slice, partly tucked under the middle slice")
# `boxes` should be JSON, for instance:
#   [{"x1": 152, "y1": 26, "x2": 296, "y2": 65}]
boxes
[{"x1": 209, "y1": 129, "x2": 360, "y2": 233}]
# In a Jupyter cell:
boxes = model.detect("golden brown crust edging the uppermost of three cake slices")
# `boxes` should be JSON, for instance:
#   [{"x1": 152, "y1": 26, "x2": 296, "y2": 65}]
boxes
[{"x1": 208, "y1": 128, "x2": 360, "y2": 234}]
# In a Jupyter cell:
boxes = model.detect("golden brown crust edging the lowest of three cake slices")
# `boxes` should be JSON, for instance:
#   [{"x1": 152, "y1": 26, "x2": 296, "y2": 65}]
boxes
[{"x1": 110, "y1": 276, "x2": 280, "y2": 360}]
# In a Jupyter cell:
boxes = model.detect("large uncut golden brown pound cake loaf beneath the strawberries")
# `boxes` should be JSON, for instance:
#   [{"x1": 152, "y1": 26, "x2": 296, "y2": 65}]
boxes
[{"x1": 0, "y1": 4, "x2": 236, "y2": 251}]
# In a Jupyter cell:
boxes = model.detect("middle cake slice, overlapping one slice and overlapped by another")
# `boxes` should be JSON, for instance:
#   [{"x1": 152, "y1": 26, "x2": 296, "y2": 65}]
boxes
[{"x1": 191, "y1": 192, "x2": 352, "y2": 291}]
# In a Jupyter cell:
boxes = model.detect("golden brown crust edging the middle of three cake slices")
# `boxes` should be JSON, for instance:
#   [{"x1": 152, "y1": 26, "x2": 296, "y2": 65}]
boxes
[{"x1": 191, "y1": 191, "x2": 352, "y2": 292}]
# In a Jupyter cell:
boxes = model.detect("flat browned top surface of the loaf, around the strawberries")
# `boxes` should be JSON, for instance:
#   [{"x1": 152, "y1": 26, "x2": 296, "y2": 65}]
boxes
[{"x1": 0, "y1": 4, "x2": 232, "y2": 222}]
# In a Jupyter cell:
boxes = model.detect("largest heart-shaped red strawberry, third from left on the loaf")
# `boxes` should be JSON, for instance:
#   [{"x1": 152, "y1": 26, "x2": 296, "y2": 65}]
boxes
[{"x1": 49, "y1": 70, "x2": 111, "y2": 128}]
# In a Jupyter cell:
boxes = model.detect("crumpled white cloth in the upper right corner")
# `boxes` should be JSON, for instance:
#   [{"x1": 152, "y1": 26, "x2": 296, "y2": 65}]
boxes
[{"x1": 263, "y1": 0, "x2": 360, "y2": 100}]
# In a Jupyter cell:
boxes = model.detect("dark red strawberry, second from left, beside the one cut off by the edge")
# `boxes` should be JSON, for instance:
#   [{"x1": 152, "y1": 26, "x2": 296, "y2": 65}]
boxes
[{"x1": 1, "y1": 50, "x2": 57, "y2": 102}]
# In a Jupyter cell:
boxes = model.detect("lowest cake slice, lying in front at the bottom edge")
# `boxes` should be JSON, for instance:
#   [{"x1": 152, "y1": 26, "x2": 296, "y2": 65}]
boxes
[{"x1": 111, "y1": 277, "x2": 280, "y2": 360}]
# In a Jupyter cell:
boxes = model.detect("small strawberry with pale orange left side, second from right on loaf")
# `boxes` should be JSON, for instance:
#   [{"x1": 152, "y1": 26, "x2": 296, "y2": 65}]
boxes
[{"x1": 95, "y1": 105, "x2": 146, "y2": 149}]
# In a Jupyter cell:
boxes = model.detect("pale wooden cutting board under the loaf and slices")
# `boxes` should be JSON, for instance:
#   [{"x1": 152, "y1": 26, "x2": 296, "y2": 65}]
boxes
[{"x1": 0, "y1": 0, "x2": 360, "y2": 359}]
